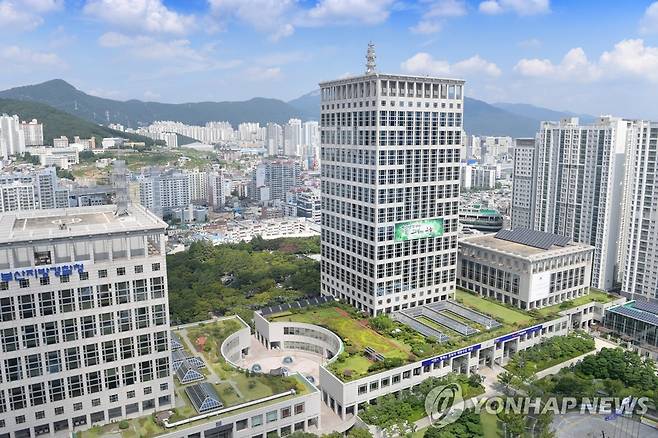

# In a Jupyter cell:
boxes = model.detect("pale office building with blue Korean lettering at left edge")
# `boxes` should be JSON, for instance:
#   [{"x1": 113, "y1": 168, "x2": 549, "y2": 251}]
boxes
[{"x1": 0, "y1": 205, "x2": 174, "y2": 437}]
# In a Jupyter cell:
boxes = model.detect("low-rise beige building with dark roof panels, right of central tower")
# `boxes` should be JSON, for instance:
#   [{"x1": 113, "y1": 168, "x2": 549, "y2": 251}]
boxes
[{"x1": 457, "y1": 229, "x2": 594, "y2": 309}]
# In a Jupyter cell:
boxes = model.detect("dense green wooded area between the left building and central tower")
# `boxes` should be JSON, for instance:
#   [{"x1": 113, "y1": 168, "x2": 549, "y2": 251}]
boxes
[{"x1": 167, "y1": 237, "x2": 320, "y2": 324}]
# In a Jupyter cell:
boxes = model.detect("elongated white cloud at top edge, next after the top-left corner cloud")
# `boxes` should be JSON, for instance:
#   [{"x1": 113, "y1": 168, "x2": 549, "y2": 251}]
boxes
[{"x1": 84, "y1": 0, "x2": 195, "y2": 35}]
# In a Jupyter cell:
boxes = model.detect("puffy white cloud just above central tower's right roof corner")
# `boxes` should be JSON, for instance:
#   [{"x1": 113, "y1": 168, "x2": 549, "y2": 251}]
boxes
[{"x1": 401, "y1": 52, "x2": 501, "y2": 77}]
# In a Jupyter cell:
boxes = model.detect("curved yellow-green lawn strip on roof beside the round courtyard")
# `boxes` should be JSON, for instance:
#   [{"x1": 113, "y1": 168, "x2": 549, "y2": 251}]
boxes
[{"x1": 270, "y1": 307, "x2": 411, "y2": 359}]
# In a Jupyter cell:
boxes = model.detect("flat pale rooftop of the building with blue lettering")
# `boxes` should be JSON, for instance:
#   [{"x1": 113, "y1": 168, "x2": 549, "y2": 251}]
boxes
[{"x1": 0, "y1": 205, "x2": 167, "y2": 243}]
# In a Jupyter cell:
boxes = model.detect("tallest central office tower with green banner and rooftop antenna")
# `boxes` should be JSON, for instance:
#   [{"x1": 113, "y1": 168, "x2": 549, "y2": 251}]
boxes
[{"x1": 320, "y1": 45, "x2": 464, "y2": 315}]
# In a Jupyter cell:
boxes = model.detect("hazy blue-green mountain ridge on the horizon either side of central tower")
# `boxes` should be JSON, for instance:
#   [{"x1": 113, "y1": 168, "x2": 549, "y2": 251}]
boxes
[{"x1": 0, "y1": 79, "x2": 591, "y2": 137}]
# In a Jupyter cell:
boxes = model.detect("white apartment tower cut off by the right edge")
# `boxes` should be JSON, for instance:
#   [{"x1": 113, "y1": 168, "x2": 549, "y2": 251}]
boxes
[{"x1": 619, "y1": 121, "x2": 658, "y2": 298}]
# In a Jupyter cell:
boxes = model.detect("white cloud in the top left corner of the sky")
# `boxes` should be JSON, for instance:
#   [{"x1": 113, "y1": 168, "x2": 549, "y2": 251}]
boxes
[{"x1": 0, "y1": 0, "x2": 63, "y2": 32}]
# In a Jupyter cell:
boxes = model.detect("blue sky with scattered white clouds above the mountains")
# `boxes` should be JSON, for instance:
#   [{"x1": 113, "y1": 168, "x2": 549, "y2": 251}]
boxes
[{"x1": 0, "y1": 0, "x2": 658, "y2": 119}]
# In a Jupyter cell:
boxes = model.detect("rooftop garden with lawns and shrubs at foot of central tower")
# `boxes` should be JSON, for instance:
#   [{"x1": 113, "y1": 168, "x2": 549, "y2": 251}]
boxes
[{"x1": 268, "y1": 289, "x2": 615, "y2": 381}]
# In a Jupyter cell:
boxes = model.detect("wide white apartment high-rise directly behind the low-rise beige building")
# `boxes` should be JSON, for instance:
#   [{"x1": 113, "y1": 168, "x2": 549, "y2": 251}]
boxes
[{"x1": 512, "y1": 116, "x2": 632, "y2": 290}]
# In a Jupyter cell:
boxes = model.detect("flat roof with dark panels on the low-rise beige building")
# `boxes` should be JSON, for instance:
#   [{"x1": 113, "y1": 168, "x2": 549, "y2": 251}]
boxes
[{"x1": 460, "y1": 230, "x2": 593, "y2": 260}]
